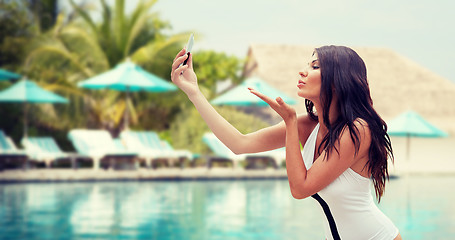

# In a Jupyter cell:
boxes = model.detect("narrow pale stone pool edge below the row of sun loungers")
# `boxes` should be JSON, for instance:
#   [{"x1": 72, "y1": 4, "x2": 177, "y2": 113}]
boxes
[{"x1": 0, "y1": 168, "x2": 287, "y2": 183}]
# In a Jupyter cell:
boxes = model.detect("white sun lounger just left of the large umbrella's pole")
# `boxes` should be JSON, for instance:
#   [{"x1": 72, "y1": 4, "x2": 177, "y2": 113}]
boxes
[{"x1": 68, "y1": 129, "x2": 137, "y2": 170}]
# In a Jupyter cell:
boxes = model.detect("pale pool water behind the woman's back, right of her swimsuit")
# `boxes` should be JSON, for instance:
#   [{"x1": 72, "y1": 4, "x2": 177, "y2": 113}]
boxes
[{"x1": 379, "y1": 175, "x2": 455, "y2": 239}]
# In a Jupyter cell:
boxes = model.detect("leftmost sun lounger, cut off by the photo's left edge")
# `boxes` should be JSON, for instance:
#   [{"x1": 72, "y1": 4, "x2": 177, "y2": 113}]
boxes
[{"x1": 0, "y1": 130, "x2": 28, "y2": 171}]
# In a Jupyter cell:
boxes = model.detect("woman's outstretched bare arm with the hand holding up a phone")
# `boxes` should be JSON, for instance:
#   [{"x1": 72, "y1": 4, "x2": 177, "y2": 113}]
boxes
[{"x1": 171, "y1": 49, "x2": 286, "y2": 154}]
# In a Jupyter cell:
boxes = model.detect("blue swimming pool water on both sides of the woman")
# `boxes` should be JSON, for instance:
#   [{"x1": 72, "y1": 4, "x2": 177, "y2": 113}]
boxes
[{"x1": 0, "y1": 176, "x2": 455, "y2": 240}]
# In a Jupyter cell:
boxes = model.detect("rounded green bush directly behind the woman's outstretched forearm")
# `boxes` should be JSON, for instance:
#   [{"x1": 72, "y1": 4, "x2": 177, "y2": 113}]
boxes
[{"x1": 170, "y1": 106, "x2": 268, "y2": 154}]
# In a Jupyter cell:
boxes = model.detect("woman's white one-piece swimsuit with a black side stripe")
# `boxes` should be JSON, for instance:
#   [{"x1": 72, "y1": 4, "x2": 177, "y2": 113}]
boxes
[{"x1": 302, "y1": 124, "x2": 398, "y2": 240}]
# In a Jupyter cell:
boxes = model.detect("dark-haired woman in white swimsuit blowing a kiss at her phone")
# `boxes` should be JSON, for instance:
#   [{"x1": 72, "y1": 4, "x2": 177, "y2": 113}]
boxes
[{"x1": 171, "y1": 46, "x2": 401, "y2": 240}]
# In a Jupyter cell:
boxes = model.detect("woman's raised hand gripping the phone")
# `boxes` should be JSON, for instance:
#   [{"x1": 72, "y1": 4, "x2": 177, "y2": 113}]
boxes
[{"x1": 171, "y1": 48, "x2": 199, "y2": 97}]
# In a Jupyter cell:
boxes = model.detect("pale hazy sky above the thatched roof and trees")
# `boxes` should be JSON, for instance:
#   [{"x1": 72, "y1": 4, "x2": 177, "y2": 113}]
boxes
[{"x1": 62, "y1": 0, "x2": 455, "y2": 82}]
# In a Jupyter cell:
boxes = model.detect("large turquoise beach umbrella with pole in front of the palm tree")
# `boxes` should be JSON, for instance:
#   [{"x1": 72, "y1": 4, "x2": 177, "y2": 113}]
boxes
[{"x1": 78, "y1": 59, "x2": 177, "y2": 129}]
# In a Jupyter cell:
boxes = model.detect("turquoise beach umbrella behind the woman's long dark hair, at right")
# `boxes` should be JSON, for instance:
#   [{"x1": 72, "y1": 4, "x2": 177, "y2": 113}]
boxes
[{"x1": 387, "y1": 111, "x2": 448, "y2": 159}]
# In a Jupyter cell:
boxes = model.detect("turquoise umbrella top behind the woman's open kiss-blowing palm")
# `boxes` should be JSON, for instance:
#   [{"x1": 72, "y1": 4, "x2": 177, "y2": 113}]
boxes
[{"x1": 211, "y1": 77, "x2": 297, "y2": 107}]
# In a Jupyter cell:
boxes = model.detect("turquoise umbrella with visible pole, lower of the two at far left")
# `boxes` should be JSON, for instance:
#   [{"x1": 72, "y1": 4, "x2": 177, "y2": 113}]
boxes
[{"x1": 0, "y1": 79, "x2": 68, "y2": 138}]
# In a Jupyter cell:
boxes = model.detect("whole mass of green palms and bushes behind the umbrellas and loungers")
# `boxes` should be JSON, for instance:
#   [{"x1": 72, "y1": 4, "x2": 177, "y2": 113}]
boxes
[{"x1": 0, "y1": 0, "x2": 249, "y2": 152}]
